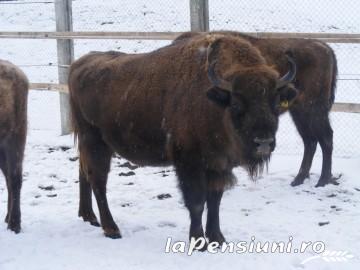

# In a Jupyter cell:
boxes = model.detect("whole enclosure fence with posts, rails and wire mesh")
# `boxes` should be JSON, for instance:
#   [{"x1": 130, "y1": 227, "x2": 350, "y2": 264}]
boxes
[{"x1": 0, "y1": 0, "x2": 360, "y2": 156}]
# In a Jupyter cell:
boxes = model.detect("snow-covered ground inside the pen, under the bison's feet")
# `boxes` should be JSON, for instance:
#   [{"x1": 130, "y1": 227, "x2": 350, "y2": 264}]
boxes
[{"x1": 0, "y1": 135, "x2": 360, "y2": 270}]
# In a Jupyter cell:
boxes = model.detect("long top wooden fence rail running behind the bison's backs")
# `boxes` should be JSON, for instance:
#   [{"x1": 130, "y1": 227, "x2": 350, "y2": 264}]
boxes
[{"x1": 0, "y1": 31, "x2": 360, "y2": 43}]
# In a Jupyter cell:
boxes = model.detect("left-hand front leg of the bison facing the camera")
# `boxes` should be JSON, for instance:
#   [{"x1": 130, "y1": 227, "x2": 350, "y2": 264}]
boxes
[{"x1": 176, "y1": 164, "x2": 207, "y2": 249}]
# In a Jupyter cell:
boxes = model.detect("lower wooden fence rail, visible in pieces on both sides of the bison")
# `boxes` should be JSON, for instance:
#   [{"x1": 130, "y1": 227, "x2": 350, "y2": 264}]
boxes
[{"x1": 30, "y1": 83, "x2": 360, "y2": 113}]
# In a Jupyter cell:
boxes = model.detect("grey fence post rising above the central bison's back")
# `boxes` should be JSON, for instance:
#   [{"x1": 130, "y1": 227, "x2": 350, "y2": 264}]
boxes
[{"x1": 190, "y1": 0, "x2": 209, "y2": 32}]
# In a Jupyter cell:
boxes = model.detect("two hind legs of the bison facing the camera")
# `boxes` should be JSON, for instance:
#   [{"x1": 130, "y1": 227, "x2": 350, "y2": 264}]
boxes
[{"x1": 78, "y1": 126, "x2": 121, "y2": 238}]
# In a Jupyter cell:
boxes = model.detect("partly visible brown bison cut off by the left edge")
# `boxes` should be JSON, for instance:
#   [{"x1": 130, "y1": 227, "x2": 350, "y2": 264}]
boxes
[{"x1": 0, "y1": 60, "x2": 29, "y2": 233}]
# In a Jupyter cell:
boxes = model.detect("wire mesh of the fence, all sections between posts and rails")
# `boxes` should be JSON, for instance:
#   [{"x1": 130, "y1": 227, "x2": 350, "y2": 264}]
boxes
[{"x1": 0, "y1": 0, "x2": 360, "y2": 156}]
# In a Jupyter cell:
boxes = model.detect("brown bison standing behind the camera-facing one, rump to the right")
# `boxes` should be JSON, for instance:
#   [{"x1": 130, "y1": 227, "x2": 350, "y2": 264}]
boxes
[{"x1": 174, "y1": 31, "x2": 338, "y2": 187}]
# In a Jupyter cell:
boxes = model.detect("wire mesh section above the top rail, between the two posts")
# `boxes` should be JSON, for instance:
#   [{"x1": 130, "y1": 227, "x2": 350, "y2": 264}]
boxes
[{"x1": 73, "y1": 0, "x2": 190, "y2": 32}]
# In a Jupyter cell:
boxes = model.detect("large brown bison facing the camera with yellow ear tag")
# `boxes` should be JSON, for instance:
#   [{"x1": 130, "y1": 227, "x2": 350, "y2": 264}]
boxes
[{"x1": 69, "y1": 35, "x2": 296, "y2": 243}]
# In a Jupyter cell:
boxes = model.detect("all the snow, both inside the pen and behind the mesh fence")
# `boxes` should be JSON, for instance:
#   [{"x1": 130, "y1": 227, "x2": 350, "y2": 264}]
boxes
[{"x1": 0, "y1": 0, "x2": 360, "y2": 270}]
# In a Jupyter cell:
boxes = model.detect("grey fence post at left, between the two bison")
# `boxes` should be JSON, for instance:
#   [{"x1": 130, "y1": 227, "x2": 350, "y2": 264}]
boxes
[{"x1": 55, "y1": 0, "x2": 74, "y2": 135}]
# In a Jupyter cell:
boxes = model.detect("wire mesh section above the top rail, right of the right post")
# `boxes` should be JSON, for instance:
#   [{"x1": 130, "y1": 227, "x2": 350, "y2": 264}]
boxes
[{"x1": 209, "y1": 0, "x2": 360, "y2": 33}]
